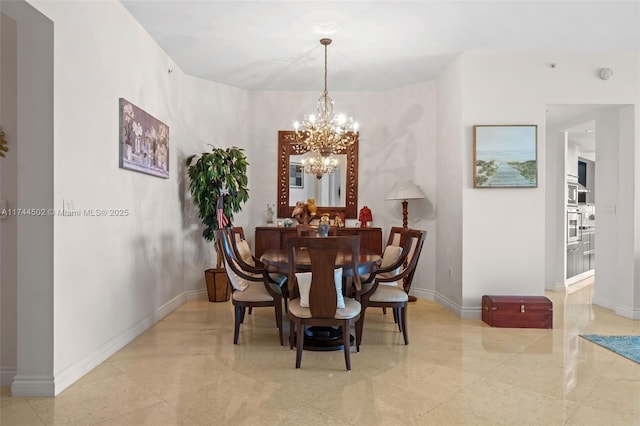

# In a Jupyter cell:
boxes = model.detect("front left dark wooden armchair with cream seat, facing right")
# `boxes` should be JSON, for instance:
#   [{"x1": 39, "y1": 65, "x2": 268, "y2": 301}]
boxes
[{"x1": 214, "y1": 229, "x2": 284, "y2": 345}]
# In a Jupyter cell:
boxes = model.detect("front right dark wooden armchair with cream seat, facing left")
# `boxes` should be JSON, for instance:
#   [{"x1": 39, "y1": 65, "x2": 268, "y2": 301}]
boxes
[{"x1": 356, "y1": 229, "x2": 427, "y2": 350}]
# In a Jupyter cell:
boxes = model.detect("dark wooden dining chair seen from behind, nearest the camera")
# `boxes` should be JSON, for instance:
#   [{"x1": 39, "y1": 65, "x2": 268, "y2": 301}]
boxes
[{"x1": 287, "y1": 235, "x2": 361, "y2": 370}]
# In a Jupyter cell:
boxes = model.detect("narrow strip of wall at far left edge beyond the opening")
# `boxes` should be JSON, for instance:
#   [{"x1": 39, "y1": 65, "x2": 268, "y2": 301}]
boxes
[{"x1": 0, "y1": 14, "x2": 18, "y2": 386}]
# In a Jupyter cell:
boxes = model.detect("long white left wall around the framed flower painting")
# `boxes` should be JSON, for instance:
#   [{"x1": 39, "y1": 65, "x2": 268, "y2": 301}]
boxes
[{"x1": 5, "y1": 1, "x2": 249, "y2": 395}]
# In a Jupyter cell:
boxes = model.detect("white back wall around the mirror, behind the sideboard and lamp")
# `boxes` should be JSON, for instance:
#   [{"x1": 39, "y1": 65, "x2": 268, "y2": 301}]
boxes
[{"x1": 248, "y1": 82, "x2": 436, "y2": 297}]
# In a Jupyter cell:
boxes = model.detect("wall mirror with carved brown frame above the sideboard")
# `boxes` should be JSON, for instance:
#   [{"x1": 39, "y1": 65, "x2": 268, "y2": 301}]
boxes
[{"x1": 278, "y1": 130, "x2": 358, "y2": 219}]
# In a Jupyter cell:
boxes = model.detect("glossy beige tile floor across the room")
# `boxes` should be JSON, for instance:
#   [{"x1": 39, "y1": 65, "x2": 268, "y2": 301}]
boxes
[{"x1": 0, "y1": 278, "x2": 640, "y2": 426}]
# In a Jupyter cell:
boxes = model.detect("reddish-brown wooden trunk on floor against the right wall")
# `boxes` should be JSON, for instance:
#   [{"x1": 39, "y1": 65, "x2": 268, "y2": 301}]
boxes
[{"x1": 482, "y1": 295, "x2": 553, "y2": 328}]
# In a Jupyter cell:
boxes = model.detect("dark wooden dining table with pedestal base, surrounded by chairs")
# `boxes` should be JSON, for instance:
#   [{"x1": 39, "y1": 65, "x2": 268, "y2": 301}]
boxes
[{"x1": 260, "y1": 248, "x2": 382, "y2": 351}]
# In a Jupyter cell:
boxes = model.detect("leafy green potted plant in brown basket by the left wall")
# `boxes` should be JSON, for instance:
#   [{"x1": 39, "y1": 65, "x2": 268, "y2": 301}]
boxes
[{"x1": 186, "y1": 146, "x2": 249, "y2": 302}]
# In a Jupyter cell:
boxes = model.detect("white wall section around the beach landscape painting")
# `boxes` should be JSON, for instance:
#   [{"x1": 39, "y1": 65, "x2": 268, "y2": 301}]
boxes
[{"x1": 462, "y1": 54, "x2": 639, "y2": 315}]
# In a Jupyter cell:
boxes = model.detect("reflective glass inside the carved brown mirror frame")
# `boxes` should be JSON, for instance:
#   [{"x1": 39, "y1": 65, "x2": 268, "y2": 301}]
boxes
[{"x1": 289, "y1": 154, "x2": 347, "y2": 207}]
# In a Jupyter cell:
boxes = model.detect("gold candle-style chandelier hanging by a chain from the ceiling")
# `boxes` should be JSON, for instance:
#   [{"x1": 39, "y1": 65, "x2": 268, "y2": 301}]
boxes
[{"x1": 293, "y1": 38, "x2": 358, "y2": 158}]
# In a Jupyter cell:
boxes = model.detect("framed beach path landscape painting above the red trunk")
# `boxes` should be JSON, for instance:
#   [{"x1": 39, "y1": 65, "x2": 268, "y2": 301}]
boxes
[{"x1": 473, "y1": 124, "x2": 538, "y2": 188}]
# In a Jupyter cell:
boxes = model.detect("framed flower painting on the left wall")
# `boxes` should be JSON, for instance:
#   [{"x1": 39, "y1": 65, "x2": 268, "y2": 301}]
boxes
[{"x1": 119, "y1": 98, "x2": 169, "y2": 178}]
